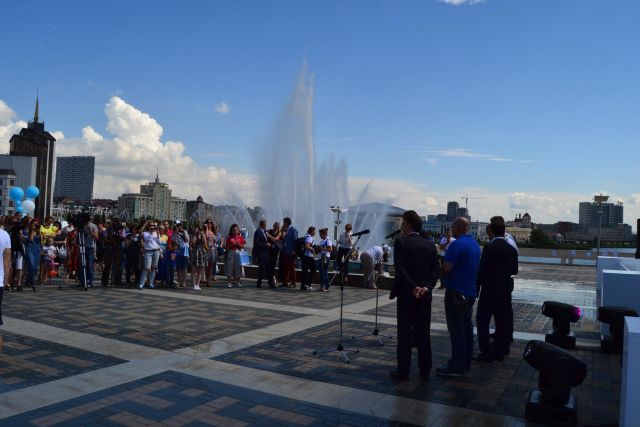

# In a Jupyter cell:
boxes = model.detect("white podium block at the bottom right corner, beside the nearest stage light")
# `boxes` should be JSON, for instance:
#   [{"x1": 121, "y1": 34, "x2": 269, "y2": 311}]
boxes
[{"x1": 620, "y1": 317, "x2": 640, "y2": 427}]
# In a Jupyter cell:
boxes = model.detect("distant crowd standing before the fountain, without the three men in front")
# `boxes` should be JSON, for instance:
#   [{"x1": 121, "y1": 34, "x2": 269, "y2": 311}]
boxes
[{"x1": 0, "y1": 213, "x2": 382, "y2": 292}]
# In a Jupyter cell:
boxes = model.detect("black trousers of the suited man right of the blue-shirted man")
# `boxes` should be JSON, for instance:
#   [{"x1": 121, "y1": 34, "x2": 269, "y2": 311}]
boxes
[{"x1": 476, "y1": 294, "x2": 513, "y2": 356}]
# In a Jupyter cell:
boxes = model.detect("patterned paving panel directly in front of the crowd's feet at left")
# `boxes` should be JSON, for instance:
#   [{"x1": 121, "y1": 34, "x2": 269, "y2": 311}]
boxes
[{"x1": 3, "y1": 287, "x2": 299, "y2": 350}]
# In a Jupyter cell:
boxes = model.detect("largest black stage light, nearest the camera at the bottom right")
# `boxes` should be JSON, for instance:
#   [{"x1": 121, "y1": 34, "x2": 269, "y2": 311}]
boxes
[{"x1": 523, "y1": 341, "x2": 587, "y2": 425}]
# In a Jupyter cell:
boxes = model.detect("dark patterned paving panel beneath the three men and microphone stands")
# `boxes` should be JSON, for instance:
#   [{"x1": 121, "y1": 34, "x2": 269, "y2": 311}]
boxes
[{"x1": 218, "y1": 321, "x2": 620, "y2": 424}]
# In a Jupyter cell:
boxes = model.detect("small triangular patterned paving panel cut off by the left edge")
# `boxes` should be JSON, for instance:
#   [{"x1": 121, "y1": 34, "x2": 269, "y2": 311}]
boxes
[{"x1": 0, "y1": 332, "x2": 125, "y2": 394}]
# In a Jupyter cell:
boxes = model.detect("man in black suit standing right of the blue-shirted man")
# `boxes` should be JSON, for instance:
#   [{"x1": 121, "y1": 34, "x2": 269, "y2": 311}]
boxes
[{"x1": 476, "y1": 222, "x2": 518, "y2": 362}]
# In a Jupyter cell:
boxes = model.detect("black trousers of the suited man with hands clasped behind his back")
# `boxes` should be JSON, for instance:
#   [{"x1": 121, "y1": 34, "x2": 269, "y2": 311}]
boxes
[{"x1": 397, "y1": 296, "x2": 432, "y2": 375}]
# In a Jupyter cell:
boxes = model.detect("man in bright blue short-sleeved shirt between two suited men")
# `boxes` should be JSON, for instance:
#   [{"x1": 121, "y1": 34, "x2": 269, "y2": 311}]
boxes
[{"x1": 436, "y1": 218, "x2": 480, "y2": 376}]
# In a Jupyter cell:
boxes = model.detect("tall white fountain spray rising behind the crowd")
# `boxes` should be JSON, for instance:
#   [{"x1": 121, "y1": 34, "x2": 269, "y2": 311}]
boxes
[{"x1": 217, "y1": 65, "x2": 388, "y2": 247}]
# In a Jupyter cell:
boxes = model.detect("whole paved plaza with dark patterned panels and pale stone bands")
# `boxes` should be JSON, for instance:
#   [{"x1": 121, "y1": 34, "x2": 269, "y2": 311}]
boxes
[{"x1": 0, "y1": 264, "x2": 621, "y2": 426}]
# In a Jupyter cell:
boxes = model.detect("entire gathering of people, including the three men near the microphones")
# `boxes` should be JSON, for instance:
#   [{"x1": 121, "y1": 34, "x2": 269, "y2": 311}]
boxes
[{"x1": 0, "y1": 211, "x2": 518, "y2": 381}]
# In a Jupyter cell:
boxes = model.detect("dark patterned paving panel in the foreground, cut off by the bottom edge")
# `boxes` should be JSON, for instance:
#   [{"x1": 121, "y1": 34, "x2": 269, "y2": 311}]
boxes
[{"x1": 2, "y1": 371, "x2": 398, "y2": 427}]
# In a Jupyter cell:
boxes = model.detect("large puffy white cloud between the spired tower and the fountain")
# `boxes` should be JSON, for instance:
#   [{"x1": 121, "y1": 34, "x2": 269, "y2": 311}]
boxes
[{"x1": 57, "y1": 96, "x2": 252, "y2": 203}]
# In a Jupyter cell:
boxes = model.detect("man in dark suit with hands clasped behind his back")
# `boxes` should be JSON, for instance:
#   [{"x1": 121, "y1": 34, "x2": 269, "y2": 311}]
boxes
[{"x1": 389, "y1": 211, "x2": 440, "y2": 381}]
